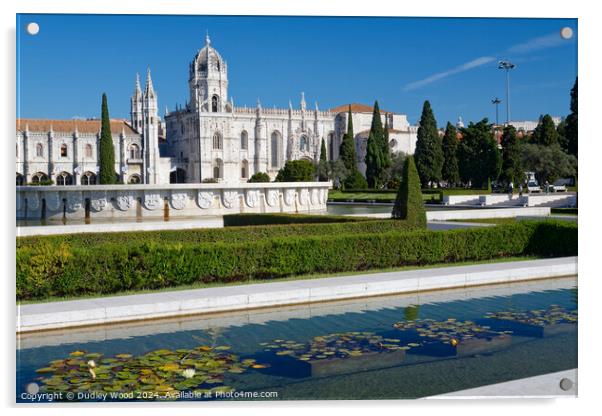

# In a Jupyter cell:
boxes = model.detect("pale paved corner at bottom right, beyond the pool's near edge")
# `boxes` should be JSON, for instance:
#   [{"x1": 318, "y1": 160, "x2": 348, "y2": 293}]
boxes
[{"x1": 427, "y1": 368, "x2": 578, "y2": 399}]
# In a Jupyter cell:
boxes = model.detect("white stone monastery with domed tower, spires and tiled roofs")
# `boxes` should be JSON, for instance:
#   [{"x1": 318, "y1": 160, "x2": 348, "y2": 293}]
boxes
[{"x1": 16, "y1": 36, "x2": 417, "y2": 185}]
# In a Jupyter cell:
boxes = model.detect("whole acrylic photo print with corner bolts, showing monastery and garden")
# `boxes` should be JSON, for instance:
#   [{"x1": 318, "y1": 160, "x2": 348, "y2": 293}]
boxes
[{"x1": 16, "y1": 14, "x2": 578, "y2": 403}]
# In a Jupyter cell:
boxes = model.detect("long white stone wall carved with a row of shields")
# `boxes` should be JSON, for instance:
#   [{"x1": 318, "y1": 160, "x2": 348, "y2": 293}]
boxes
[{"x1": 16, "y1": 182, "x2": 332, "y2": 220}]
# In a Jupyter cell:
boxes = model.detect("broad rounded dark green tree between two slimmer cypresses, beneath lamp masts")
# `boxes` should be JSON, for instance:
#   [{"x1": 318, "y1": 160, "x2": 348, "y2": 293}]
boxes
[{"x1": 458, "y1": 118, "x2": 502, "y2": 188}]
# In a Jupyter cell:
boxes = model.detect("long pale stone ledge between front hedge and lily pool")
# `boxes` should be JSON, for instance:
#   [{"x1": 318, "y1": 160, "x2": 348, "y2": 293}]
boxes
[{"x1": 16, "y1": 257, "x2": 577, "y2": 332}]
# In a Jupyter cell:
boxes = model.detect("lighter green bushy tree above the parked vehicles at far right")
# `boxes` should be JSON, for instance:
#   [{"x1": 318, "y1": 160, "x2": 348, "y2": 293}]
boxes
[{"x1": 522, "y1": 143, "x2": 577, "y2": 184}]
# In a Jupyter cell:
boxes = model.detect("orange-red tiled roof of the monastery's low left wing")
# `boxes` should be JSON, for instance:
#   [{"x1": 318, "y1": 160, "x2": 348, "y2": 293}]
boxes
[{"x1": 17, "y1": 118, "x2": 138, "y2": 134}]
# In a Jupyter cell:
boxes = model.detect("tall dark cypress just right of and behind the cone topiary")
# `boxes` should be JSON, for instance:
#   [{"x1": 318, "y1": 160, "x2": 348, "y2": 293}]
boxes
[{"x1": 414, "y1": 101, "x2": 443, "y2": 187}]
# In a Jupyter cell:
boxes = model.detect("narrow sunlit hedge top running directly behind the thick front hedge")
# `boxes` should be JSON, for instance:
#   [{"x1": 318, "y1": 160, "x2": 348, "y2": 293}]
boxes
[{"x1": 17, "y1": 217, "x2": 416, "y2": 248}]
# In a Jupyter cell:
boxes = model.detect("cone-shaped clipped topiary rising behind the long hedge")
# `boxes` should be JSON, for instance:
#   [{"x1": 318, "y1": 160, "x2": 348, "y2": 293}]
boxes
[{"x1": 391, "y1": 157, "x2": 426, "y2": 228}]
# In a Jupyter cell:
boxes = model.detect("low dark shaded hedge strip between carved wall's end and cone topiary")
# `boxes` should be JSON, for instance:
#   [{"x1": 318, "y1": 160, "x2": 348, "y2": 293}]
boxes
[{"x1": 224, "y1": 214, "x2": 364, "y2": 227}]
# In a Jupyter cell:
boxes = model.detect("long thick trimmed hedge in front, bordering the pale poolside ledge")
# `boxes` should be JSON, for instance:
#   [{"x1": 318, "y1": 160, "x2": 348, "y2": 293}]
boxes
[{"x1": 16, "y1": 221, "x2": 577, "y2": 300}]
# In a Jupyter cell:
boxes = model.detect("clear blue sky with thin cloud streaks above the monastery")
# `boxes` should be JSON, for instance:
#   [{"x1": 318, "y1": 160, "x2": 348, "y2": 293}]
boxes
[{"x1": 17, "y1": 15, "x2": 577, "y2": 126}]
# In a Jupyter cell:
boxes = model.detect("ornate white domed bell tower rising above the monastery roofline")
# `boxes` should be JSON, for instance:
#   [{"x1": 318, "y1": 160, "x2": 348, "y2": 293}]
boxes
[{"x1": 188, "y1": 34, "x2": 228, "y2": 113}]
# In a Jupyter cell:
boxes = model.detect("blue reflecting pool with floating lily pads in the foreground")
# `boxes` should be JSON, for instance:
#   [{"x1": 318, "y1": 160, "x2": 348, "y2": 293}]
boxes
[{"x1": 17, "y1": 277, "x2": 577, "y2": 401}]
